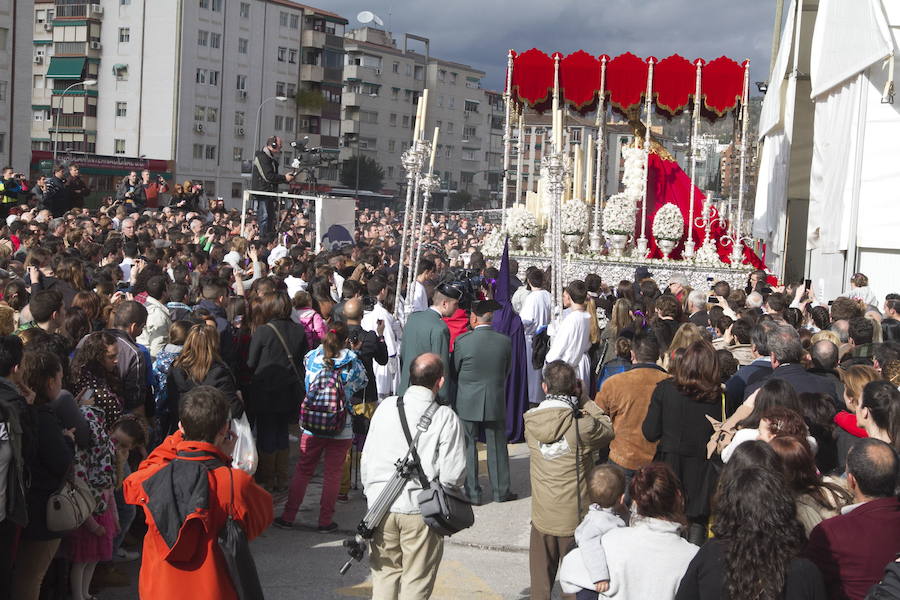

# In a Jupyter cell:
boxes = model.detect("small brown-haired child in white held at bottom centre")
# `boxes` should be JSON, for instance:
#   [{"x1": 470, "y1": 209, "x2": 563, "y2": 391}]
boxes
[{"x1": 559, "y1": 464, "x2": 625, "y2": 600}]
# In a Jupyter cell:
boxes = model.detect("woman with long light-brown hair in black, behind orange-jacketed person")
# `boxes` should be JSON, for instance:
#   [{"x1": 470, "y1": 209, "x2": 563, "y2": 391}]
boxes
[{"x1": 166, "y1": 323, "x2": 244, "y2": 435}]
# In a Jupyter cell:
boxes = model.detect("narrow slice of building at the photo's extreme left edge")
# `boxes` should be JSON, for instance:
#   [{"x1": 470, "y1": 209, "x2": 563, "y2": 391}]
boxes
[{"x1": 0, "y1": 0, "x2": 32, "y2": 171}]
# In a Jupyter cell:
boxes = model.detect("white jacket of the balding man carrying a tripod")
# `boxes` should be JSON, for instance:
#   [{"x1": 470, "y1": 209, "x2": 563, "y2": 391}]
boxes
[{"x1": 360, "y1": 385, "x2": 466, "y2": 515}]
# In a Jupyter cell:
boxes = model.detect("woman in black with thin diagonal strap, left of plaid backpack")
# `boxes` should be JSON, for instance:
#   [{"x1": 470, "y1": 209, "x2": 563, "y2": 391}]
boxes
[{"x1": 247, "y1": 292, "x2": 309, "y2": 491}]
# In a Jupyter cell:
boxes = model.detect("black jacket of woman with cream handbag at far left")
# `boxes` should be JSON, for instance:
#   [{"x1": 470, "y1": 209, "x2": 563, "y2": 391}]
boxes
[{"x1": 22, "y1": 404, "x2": 75, "y2": 540}]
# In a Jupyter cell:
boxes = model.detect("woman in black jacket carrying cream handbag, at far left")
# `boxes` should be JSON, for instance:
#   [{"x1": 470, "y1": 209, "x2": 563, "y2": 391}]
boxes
[{"x1": 12, "y1": 350, "x2": 75, "y2": 600}]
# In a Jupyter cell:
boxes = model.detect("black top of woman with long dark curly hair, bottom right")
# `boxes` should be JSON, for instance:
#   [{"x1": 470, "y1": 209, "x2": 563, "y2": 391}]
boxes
[{"x1": 675, "y1": 539, "x2": 828, "y2": 600}]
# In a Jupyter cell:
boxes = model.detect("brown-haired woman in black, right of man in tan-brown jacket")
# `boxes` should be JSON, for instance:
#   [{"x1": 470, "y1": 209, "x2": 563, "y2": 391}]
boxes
[{"x1": 642, "y1": 341, "x2": 722, "y2": 545}]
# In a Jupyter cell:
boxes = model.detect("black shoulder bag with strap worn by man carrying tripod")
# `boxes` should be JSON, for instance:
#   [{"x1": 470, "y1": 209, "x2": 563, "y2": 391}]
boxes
[{"x1": 397, "y1": 396, "x2": 475, "y2": 536}]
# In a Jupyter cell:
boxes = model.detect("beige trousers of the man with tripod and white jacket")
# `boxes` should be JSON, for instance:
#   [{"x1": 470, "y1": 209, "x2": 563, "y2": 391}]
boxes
[{"x1": 370, "y1": 513, "x2": 444, "y2": 600}]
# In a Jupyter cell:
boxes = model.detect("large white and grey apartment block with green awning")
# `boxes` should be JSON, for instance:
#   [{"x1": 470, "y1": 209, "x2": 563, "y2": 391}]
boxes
[{"x1": 31, "y1": 0, "x2": 347, "y2": 206}]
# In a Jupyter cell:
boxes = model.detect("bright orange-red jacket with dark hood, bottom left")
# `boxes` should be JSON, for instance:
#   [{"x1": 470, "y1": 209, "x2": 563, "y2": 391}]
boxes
[{"x1": 123, "y1": 432, "x2": 273, "y2": 600}]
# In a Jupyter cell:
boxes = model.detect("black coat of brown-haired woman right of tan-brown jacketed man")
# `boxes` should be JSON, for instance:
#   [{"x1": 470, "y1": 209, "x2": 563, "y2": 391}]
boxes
[{"x1": 642, "y1": 379, "x2": 722, "y2": 520}]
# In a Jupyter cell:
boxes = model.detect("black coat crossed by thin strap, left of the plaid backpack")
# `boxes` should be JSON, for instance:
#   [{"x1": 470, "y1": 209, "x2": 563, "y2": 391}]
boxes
[{"x1": 246, "y1": 319, "x2": 309, "y2": 414}]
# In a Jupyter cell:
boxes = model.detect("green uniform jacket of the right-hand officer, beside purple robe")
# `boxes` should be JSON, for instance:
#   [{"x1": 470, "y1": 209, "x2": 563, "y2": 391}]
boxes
[{"x1": 453, "y1": 326, "x2": 512, "y2": 421}]
